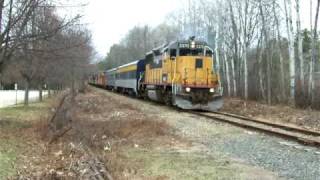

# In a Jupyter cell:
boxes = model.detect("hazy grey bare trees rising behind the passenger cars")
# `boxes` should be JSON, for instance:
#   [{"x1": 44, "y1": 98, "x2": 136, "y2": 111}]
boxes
[{"x1": 99, "y1": 24, "x2": 180, "y2": 70}]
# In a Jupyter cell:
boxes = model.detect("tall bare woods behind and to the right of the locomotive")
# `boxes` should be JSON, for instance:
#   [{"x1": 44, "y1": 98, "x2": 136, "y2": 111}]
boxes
[{"x1": 101, "y1": 0, "x2": 320, "y2": 108}]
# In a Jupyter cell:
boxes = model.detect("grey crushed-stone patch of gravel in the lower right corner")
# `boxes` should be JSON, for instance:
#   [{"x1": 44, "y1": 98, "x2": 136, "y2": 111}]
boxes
[{"x1": 209, "y1": 133, "x2": 320, "y2": 180}]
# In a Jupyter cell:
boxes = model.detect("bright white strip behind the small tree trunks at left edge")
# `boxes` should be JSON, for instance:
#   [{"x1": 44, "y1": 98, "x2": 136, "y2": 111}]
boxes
[{"x1": 0, "y1": 90, "x2": 48, "y2": 108}]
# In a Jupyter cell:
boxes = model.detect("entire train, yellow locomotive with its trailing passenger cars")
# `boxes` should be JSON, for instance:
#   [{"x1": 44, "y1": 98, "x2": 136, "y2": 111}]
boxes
[{"x1": 89, "y1": 37, "x2": 223, "y2": 111}]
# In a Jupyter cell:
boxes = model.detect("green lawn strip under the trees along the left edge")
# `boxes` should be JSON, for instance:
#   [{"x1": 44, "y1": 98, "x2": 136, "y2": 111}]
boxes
[{"x1": 0, "y1": 99, "x2": 52, "y2": 179}]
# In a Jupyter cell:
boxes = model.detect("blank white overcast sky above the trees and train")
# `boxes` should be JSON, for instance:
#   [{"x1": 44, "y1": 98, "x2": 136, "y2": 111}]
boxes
[{"x1": 64, "y1": 0, "x2": 316, "y2": 56}]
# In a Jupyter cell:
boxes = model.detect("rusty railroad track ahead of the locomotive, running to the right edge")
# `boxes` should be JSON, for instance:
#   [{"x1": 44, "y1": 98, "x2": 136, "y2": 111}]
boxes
[{"x1": 192, "y1": 112, "x2": 320, "y2": 147}]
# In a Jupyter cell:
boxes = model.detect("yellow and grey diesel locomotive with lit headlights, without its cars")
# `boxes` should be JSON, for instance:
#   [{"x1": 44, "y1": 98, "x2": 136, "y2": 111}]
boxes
[{"x1": 138, "y1": 38, "x2": 223, "y2": 111}]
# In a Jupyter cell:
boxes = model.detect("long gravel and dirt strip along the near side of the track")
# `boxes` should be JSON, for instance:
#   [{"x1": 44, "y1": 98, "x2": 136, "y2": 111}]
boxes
[{"x1": 99, "y1": 90, "x2": 320, "y2": 180}]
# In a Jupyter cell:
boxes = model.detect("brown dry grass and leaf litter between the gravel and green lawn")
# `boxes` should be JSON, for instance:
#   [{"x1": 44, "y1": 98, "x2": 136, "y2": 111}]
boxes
[{"x1": 6, "y1": 88, "x2": 282, "y2": 180}]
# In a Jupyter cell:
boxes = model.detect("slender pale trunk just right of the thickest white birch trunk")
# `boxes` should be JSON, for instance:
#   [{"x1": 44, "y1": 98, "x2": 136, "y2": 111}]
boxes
[{"x1": 296, "y1": 0, "x2": 305, "y2": 90}]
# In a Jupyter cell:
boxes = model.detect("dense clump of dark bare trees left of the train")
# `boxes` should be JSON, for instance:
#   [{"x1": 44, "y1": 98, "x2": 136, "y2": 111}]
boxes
[{"x1": 0, "y1": 0, "x2": 93, "y2": 105}]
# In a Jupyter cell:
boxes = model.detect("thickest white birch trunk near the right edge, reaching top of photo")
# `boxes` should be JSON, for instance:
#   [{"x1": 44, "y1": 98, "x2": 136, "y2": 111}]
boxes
[{"x1": 284, "y1": 0, "x2": 296, "y2": 105}]
